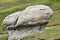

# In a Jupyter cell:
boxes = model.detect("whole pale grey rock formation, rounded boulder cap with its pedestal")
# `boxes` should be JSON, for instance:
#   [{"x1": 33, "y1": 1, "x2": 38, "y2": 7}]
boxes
[{"x1": 3, "y1": 5, "x2": 53, "y2": 40}]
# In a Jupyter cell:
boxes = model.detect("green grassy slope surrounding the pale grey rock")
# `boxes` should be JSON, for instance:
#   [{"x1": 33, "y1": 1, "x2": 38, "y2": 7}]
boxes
[{"x1": 0, "y1": 0, "x2": 60, "y2": 40}]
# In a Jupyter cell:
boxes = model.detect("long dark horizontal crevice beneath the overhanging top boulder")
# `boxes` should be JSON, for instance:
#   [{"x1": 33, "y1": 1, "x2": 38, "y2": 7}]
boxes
[{"x1": 8, "y1": 22, "x2": 48, "y2": 30}]
